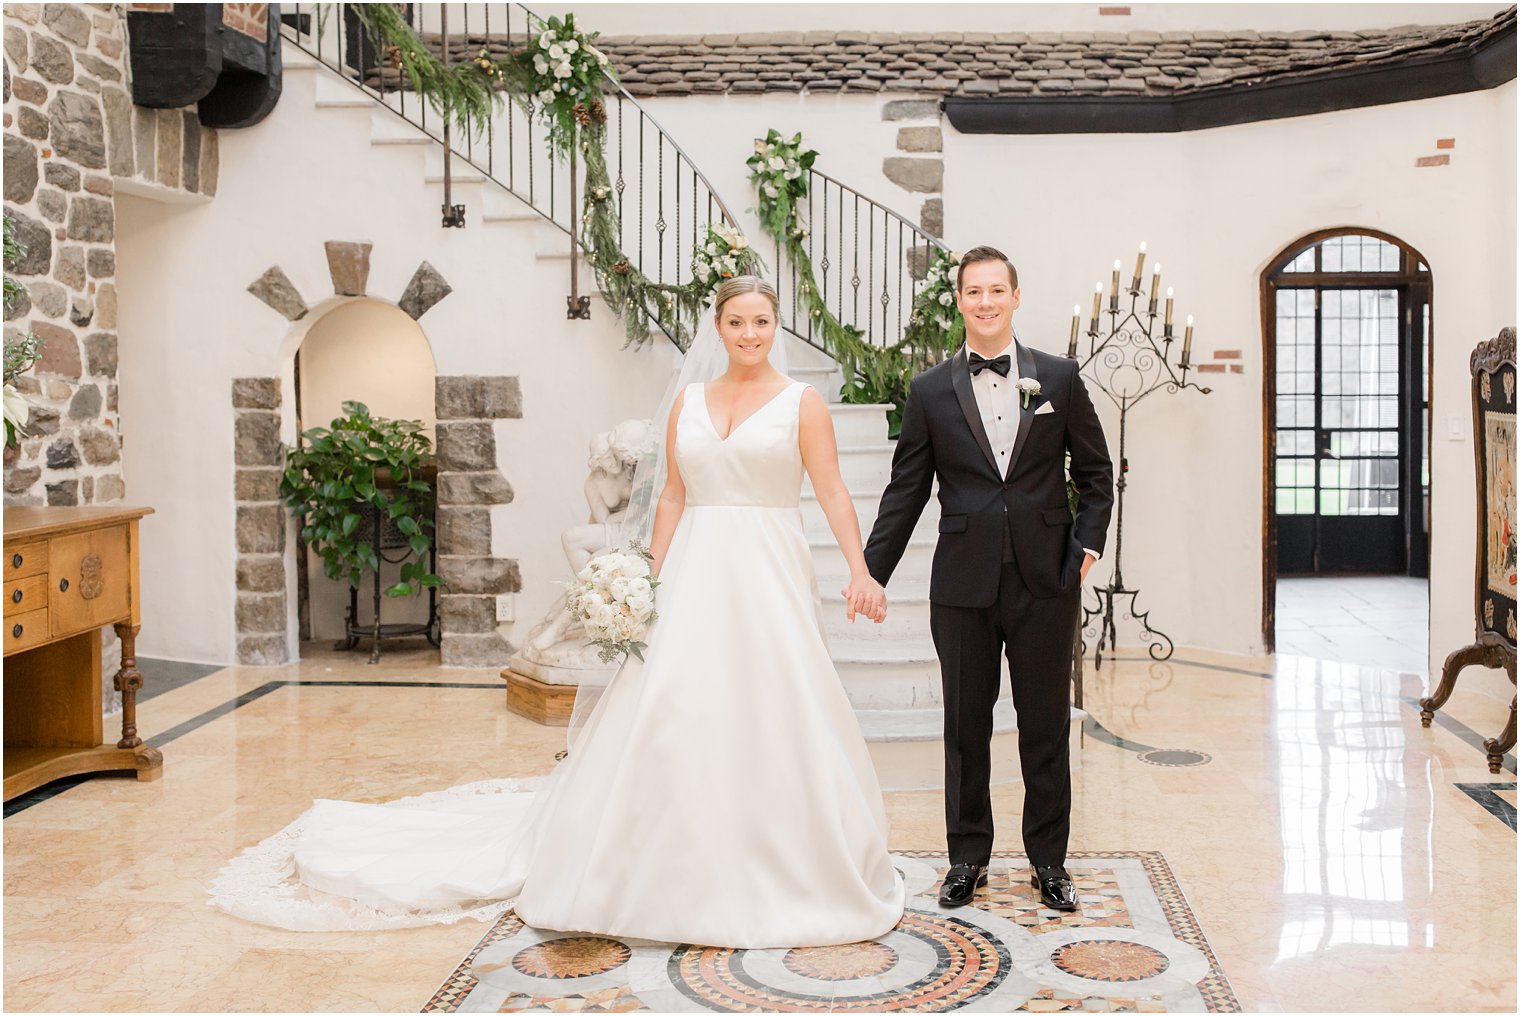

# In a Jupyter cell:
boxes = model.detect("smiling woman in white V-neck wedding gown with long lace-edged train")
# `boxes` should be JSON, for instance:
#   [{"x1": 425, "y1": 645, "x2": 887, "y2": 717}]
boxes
[{"x1": 211, "y1": 275, "x2": 904, "y2": 949}]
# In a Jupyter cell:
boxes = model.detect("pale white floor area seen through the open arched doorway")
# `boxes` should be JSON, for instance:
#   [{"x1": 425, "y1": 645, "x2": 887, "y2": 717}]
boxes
[{"x1": 1277, "y1": 575, "x2": 1430, "y2": 675}]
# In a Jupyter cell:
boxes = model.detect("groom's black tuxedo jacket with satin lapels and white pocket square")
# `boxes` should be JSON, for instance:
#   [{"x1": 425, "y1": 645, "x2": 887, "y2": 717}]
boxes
[{"x1": 865, "y1": 342, "x2": 1114, "y2": 607}]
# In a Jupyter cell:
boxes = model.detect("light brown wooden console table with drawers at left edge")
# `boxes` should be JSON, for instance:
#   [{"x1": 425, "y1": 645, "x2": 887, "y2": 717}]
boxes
[{"x1": 3, "y1": 506, "x2": 164, "y2": 800}]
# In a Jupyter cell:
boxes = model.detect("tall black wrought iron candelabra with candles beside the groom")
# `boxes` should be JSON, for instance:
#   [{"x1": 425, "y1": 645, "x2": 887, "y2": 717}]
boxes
[{"x1": 1067, "y1": 243, "x2": 1211, "y2": 669}]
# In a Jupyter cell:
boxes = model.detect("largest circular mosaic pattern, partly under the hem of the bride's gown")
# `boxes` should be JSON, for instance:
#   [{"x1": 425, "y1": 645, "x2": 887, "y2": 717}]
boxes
[{"x1": 666, "y1": 911, "x2": 1012, "y2": 1013}]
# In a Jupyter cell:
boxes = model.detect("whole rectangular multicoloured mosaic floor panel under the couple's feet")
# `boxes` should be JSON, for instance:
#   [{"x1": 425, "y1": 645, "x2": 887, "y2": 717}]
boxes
[{"x1": 423, "y1": 852, "x2": 1240, "y2": 1013}]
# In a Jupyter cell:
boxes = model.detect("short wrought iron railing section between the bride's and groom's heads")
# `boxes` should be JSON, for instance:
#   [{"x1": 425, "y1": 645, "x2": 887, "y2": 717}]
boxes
[{"x1": 775, "y1": 169, "x2": 945, "y2": 366}]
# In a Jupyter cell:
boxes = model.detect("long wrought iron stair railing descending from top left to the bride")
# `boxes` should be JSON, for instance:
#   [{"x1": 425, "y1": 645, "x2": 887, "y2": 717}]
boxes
[{"x1": 281, "y1": 3, "x2": 736, "y2": 341}]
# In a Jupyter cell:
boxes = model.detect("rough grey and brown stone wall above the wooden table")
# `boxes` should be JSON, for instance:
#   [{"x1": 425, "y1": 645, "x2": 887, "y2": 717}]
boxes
[{"x1": 3, "y1": 3, "x2": 218, "y2": 505}]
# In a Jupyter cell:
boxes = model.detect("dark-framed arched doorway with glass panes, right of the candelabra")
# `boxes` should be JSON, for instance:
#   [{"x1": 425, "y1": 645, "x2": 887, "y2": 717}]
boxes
[{"x1": 1262, "y1": 228, "x2": 1432, "y2": 671}]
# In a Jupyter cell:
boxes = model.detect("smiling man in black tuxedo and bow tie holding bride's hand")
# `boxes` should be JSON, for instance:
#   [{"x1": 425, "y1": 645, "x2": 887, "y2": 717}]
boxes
[{"x1": 865, "y1": 246, "x2": 1114, "y2": 911}]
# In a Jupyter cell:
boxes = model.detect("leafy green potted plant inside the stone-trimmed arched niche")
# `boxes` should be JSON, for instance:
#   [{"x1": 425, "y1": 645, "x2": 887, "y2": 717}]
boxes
[{"x1": 280, "y1": 402, "x2": 441, "y2": 596}]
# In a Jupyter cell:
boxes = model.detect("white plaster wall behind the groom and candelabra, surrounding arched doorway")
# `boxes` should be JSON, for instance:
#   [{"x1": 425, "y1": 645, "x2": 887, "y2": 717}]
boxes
[{"x1": 623, "y1": 84, "x2": 1515, "y2": 663}]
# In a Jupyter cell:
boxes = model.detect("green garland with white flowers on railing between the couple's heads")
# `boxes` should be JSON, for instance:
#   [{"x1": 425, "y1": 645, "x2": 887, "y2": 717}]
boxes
[{"x1": 745, "y1": 128, "x2": 965, "y2": 437}]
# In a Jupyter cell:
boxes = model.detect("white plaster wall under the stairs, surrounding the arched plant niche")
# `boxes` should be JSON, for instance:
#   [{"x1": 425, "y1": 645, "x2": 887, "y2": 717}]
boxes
[{"x1": 117, "y1": 59, "x2": 675, "y2": 663}]
